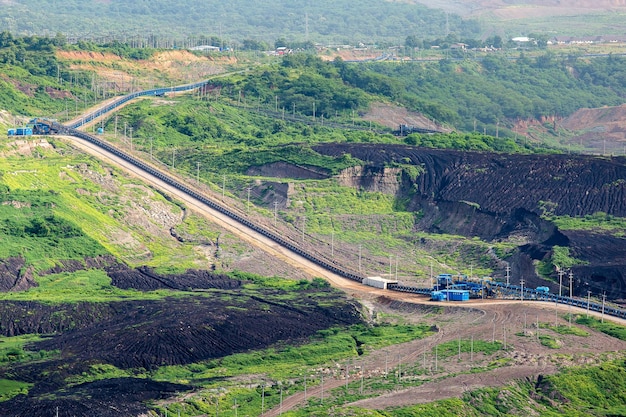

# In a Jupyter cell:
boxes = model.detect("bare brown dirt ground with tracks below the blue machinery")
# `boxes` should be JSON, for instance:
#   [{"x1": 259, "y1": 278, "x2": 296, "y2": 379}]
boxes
[{"x1": 262, "y1": 300, "x2": 626, "y2": 417}]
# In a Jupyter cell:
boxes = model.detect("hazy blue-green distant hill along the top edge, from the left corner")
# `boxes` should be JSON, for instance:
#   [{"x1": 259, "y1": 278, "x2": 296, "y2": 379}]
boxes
[{"x1": 0, "y1": 0, "x2": 478, "y2": 44}]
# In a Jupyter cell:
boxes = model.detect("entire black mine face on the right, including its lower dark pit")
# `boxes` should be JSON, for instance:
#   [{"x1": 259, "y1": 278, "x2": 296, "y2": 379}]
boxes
[{"x1": 315, "y1": 144, "x2": 626, "y2": 298}]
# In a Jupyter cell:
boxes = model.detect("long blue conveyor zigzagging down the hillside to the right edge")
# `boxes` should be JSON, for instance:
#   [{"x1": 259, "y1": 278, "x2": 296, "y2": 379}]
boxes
[{"x1": 39, "y1": 81, "x2": 626, "y2": 319}]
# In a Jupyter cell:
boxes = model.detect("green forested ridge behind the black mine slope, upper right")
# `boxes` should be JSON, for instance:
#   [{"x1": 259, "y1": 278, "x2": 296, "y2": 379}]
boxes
[{"x1": 212, "y1": 53, "x2": 626, "y2": 136}]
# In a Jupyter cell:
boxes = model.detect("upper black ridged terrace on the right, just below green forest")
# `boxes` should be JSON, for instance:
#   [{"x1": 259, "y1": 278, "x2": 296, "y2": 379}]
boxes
[{"x1": 314, "y1": 144, "x2": 626, "y2": 217}]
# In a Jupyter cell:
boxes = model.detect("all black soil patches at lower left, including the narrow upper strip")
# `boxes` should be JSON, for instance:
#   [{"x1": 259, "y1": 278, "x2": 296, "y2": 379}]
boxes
[{"x1": 0, "y1": 259, "x2": 361, "y2": 417}]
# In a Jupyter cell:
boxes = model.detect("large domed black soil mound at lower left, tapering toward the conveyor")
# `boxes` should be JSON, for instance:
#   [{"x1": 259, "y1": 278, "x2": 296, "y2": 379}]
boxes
[{"x1": 29, "y1": 292, "x2": 358, "y2": 369}]
